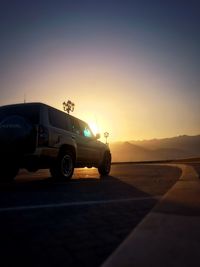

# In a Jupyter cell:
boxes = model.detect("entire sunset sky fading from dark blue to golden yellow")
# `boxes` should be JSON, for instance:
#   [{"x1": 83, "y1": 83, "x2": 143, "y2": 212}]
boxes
[{"x1": 0, "y1": 0, "x2": 200, "y2": 141}]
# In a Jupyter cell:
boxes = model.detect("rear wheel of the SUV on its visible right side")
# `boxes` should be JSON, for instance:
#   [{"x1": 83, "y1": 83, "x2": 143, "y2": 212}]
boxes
[{"x1": 50, "y1": 151, "x2": 75, "y2": 181}]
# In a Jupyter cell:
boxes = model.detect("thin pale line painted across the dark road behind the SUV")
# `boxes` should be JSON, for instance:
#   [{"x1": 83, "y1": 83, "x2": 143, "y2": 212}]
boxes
[{"x1": 0, "y1": 196, "x2": 161, "y2": 212}]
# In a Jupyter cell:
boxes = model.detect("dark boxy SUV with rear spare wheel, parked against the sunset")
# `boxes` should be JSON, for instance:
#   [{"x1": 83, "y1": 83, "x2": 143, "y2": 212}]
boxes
[{"x1": 0, "y1": 103, "x2": 111, "y2": 180}]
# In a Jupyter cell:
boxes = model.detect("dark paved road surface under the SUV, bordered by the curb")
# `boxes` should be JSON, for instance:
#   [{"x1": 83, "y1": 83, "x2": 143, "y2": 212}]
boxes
[{"x1": 0, "y1": 164, "x2": 181, "y2": 267}]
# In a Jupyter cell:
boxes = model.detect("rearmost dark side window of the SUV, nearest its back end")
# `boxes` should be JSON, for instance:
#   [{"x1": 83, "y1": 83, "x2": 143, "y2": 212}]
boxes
[{"x1": 49, "y1": 108, "x2": 70, "y2": 131}]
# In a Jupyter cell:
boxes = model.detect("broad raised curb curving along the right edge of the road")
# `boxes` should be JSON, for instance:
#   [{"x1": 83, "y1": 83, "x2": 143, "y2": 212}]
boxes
[{"x1": 101, "y1": 164, "x2": 200, "y2": 267}]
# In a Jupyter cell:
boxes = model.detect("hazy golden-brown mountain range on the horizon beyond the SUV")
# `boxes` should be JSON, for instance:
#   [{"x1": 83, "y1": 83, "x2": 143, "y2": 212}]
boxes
[{"x1": 110, "y1": 135, "x2": 200, "y2": 162}]
